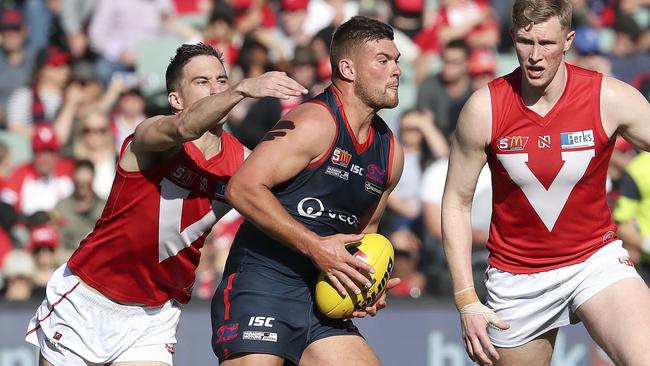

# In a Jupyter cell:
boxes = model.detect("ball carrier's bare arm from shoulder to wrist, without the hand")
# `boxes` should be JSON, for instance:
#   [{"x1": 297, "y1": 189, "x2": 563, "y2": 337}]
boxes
[{"x1": 226, "y1": 105, "x2": 335, "y2": 254}]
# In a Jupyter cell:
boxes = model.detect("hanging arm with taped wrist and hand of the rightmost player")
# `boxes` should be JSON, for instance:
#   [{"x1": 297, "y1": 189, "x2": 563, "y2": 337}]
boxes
[{"x1": 442, "y1": 87, "x2": 508, "y2": 365}]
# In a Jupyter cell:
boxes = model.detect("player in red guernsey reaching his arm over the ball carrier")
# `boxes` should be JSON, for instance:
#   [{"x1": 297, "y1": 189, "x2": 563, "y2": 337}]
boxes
[{"x1": 26, "y1": 44, "x2": 307, "y2": 365}]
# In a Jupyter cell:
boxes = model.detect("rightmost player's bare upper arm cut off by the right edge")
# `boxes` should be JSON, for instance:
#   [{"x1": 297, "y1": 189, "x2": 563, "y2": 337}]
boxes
[{"x1": 600, "y1": 77, "x2": 650, "y2": 151}]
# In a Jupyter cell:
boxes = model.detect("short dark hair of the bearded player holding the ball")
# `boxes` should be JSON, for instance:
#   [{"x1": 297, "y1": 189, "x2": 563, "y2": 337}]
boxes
[{"x1": 330, "y1": 16, "x2": 394, "y2": 77}]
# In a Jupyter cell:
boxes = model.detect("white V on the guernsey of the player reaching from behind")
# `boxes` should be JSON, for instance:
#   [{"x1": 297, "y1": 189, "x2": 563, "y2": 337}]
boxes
[{"x1": 158, "y1": 178, "x2": 230, "y2": 262}]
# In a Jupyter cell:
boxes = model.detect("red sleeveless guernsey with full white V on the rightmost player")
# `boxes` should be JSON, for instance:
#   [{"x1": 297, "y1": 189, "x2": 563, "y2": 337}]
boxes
[{"x1": 487, "y1": 64, "x2": 616, "y2": 273}]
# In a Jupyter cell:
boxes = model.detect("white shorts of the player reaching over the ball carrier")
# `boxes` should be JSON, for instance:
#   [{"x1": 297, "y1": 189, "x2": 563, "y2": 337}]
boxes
[{"x1": 25, "y1": 264, "x2": 180, "y2": 366}]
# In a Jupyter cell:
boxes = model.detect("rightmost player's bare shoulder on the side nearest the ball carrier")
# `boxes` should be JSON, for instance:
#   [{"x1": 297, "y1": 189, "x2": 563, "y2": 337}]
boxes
[{"x1": 456, "y1": 86, "x2": 492, "y2": 146}]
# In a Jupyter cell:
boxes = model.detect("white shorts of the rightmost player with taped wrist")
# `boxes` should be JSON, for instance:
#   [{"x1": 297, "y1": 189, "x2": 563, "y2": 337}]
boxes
[{"x1": 486, "y1": 240, "x2": 640, "y2": 348}]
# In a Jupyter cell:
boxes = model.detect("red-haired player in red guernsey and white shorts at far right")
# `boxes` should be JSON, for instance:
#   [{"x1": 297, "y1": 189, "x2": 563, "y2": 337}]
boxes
[{"x1": 442, "y1": 0, "x2": 650, "y2": 366}]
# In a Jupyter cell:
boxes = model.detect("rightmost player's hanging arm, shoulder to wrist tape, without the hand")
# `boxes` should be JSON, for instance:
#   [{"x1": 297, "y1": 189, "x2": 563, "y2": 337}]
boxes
[{"x1": 442, "y1": 88, "x2": 492, "y2": 291}]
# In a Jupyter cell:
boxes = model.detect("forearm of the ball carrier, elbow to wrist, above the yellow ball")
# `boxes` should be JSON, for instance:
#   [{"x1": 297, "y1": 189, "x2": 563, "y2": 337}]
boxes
[{"x1": 226, "y1": 182, "x2": 318, "y2": 256}]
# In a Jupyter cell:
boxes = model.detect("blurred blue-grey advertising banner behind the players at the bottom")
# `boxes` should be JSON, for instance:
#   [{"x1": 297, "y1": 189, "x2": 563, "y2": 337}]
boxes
[{"x1": 0, "y1": 300, "x2": 613, "y2": 366}]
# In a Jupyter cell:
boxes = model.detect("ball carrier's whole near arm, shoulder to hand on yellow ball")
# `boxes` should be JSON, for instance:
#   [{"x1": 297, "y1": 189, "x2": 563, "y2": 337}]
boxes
[{"x1": 226, "y1": 103, "x2": 372, "y2": 295}]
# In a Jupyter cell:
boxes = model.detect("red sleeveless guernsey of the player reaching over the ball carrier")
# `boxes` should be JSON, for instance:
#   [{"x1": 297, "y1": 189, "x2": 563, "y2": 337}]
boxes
[{"x1": 68, "y1": 131, "x2": 244, "y2": 306}]
